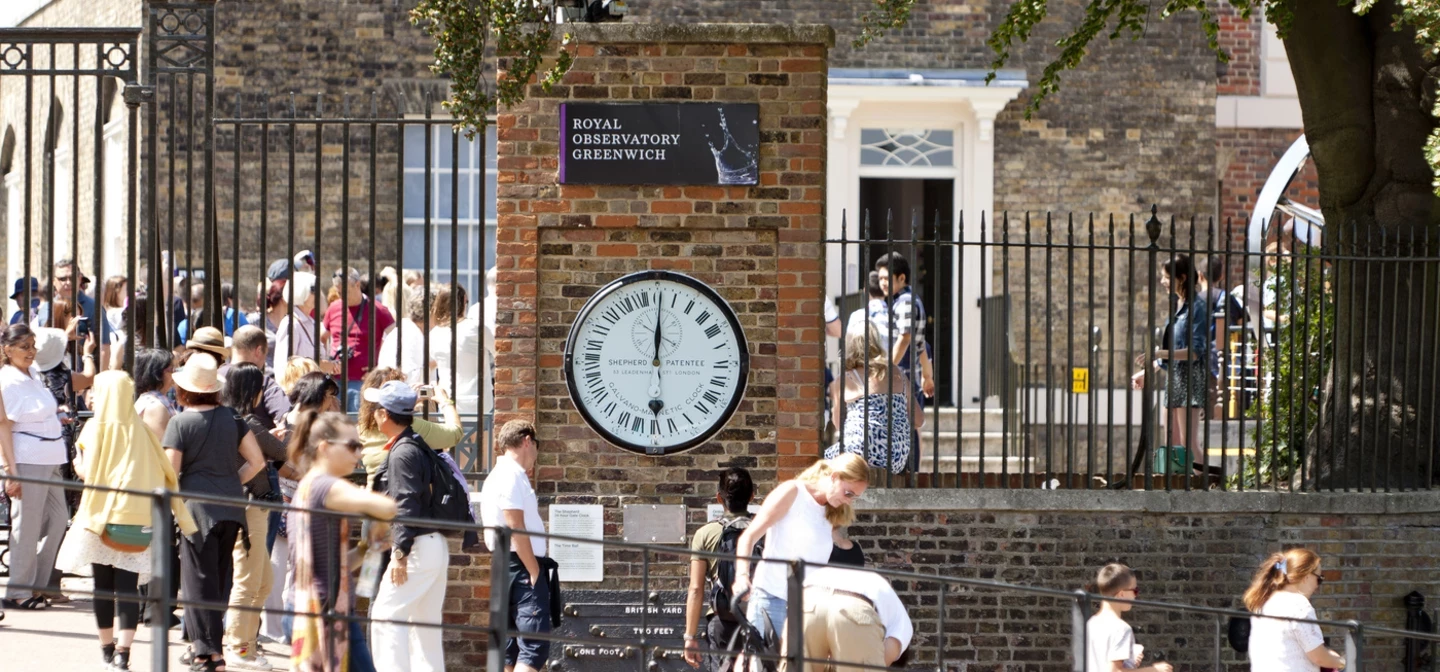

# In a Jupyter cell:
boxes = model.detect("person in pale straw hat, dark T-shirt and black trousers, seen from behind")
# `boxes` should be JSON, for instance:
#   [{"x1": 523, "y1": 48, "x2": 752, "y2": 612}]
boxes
[{"x1": 161, "y1": 352, "x2": 265, "y2": 672}]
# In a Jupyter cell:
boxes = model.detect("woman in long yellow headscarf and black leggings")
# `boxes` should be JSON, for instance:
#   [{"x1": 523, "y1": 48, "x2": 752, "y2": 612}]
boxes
[{"x1": 56, "y1": 371, "x2": 196, "y2": 671}]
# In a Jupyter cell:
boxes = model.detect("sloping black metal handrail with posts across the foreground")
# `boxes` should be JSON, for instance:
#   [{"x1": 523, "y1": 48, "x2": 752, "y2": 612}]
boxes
[{"x1": 0, "y1": 475, "x2": 1440, "y2": 672}]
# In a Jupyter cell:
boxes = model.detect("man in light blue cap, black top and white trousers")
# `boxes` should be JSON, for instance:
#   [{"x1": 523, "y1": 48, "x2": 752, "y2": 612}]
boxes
[{"x1": 364, "y1": 381, "x2": 449, "y2": 672}]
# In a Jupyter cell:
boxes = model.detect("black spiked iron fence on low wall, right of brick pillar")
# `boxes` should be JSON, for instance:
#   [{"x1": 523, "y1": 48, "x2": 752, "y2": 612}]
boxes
[{"x1": 827, "y1": 209, "x2": 1440, "y2": 491}]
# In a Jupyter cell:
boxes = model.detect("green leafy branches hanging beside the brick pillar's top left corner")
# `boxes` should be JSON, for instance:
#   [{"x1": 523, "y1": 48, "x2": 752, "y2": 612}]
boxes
[{"x1": 410, "y1": 0, "x2": 573, "y2": 140}]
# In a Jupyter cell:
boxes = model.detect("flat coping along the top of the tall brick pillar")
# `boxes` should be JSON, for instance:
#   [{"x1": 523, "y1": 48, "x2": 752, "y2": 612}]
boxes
[{"x1": 557, "y1": 22, "x2": 835, "y2": 47}]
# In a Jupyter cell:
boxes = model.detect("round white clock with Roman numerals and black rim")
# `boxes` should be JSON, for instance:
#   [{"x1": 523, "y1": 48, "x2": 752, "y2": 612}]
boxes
[{"x1": 564, "y1": 271, "x2": 750, "y2": 455}]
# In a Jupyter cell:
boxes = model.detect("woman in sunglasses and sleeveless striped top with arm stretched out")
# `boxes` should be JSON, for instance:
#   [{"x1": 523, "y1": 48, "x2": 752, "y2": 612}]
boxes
[{"x1": 289, "y1": 410, "x2": 396, "y2": 672}]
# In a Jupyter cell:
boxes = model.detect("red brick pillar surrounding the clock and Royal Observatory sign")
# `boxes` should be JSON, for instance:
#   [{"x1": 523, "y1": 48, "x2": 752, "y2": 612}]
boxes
[{"x1": 446, "y1": 23, "x2": 834, "y2": 663}]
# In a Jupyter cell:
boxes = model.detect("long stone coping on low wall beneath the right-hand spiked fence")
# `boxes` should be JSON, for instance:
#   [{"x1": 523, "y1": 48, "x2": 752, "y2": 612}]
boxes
[{"x1": 855, "y1": 488, "x2": 1440, "y2": 515}]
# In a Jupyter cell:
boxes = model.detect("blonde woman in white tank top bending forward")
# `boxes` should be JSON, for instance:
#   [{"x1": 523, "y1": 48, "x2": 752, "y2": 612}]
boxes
[{"x1": 733, "y1": 453, "x2": 870, "y2": 636}]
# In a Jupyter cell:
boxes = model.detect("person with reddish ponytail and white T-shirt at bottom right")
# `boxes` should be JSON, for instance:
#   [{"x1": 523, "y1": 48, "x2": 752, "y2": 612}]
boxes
[{"x1": 1244, "y1": 548, "x2": 1345, "y2": 672}]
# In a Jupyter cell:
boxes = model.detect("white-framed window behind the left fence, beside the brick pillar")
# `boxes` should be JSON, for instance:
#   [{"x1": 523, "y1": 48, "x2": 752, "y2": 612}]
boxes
[{"x1": 402, "y1": 124, "x2": 498, "y2": 302}]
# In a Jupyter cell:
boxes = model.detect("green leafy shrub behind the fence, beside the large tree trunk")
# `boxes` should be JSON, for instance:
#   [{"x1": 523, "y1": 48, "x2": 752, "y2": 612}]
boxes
[{"x1": 1230, "y1": 246, "x2": 1335, "y2": 488}]
